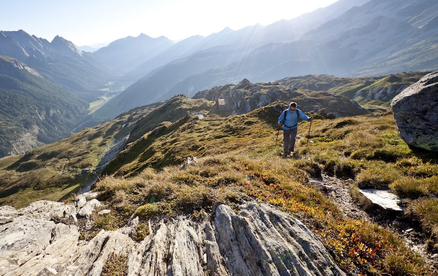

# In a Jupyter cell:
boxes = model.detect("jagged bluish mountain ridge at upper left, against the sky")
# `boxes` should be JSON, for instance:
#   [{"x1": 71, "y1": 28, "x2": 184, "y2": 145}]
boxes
[{"x1": 0, "y1": 30, "x2": 115, "y2": 94}]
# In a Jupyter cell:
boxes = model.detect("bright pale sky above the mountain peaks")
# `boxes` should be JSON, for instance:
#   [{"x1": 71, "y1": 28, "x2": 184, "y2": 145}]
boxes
[{"x1": 0, "y1": 0, "x2": 337, "y2": 46}]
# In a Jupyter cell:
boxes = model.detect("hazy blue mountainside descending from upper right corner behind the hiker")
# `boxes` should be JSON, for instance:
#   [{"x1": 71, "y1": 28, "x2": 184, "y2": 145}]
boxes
[{"x1": 96, "y1": 0, "x2": 438, "y2": 119}]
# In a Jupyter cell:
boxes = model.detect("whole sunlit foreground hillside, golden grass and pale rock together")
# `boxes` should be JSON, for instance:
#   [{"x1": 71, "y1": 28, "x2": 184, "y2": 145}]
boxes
[{"x1": 0, "y1": 84, "x2": 438, "y2": 275}]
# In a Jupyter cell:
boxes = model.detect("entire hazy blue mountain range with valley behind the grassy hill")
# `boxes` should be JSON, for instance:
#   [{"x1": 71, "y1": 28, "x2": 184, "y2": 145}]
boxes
[{"x1": 0, "y1": 0, "x2": 438, "y2": 154}]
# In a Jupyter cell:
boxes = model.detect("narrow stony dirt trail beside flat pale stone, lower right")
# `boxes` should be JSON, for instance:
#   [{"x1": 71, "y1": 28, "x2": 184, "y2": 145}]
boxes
[{"x1": 310, "y1": 175, "x2": 438, "y2": 275}]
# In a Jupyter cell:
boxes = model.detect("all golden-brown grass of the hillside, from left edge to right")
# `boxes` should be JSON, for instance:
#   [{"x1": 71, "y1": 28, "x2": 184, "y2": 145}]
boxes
[{"x1": 0, "y1": 91, "x2": 438, "y2": 275}]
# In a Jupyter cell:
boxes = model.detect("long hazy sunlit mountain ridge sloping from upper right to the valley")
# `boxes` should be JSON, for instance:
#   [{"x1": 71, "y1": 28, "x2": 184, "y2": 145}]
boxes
[{"x1": 91, "y1": 0, "x2": 438, "y2": 121}]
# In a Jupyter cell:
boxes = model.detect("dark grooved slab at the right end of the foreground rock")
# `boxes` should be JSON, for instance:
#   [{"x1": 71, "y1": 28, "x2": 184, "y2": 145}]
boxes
[{"x1": 215, "y1": 203, "x2": 344, "y2": 276}]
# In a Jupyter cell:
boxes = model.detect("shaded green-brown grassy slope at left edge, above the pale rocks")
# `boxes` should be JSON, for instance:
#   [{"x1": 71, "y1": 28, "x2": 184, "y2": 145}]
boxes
[{"x1": 0, "y1": 103, "x2": 157, "y2": 208}]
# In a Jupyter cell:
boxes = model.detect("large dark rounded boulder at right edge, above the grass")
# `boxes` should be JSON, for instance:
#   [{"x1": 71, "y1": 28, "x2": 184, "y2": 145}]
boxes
[{"x1": 391, "y1": 72, "x2": 438, "y2": 151}]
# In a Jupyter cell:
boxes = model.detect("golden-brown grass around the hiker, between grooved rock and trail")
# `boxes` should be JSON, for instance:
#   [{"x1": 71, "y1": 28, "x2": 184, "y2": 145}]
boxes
[{"x1": 91, "y1": 106, "x2": 438, "y2": 274}]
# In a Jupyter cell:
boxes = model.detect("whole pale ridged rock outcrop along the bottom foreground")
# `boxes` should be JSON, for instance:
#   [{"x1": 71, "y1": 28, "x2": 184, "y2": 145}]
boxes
[{"x1": 0, "y1": 196, "x2": 345, "y2": 276}]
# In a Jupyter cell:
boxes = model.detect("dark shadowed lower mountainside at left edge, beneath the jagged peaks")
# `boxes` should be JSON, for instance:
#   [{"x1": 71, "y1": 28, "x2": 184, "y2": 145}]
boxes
[{"x1": 0, "y1": 56, "x2": 88, "y2": 157}]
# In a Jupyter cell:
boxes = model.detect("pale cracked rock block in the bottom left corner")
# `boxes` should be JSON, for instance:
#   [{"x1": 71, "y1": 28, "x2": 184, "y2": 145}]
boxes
[{"x1": 0, "y1": 216, "x2": 79, "y2": 275}]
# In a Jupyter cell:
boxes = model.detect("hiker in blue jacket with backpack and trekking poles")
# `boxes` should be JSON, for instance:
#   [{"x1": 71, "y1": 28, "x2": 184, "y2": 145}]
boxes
[{"x1": 278, "y1": 102, "x2": 313, "y2": 158}]
